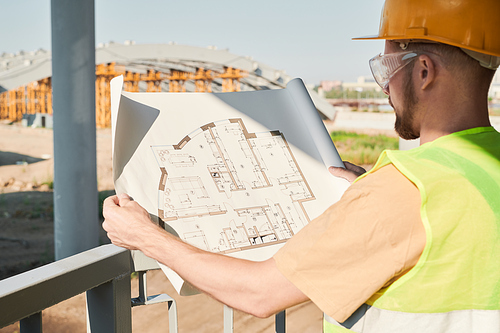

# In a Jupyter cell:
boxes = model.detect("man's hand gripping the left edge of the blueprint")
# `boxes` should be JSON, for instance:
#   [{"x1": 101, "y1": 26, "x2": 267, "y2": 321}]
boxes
[{"x1": 102, "y1": 194, "x2": 161, "y2": 250}]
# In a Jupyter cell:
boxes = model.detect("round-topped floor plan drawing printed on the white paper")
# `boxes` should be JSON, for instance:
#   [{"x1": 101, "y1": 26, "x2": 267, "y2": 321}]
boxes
[{"x1": 151, "y1": 118, "x2": 315, "y2": 253}]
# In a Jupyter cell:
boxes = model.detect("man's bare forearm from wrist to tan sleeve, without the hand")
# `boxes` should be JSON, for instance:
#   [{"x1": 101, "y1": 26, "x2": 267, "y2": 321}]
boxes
[{"x1": 142, "y1": 226, "x2": 308, "y2": 317}]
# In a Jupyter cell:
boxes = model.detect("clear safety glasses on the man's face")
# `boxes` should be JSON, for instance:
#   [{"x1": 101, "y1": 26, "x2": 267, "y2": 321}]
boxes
[{"x1": 370, "y1": 51, "x2": 418, "y2": 92}]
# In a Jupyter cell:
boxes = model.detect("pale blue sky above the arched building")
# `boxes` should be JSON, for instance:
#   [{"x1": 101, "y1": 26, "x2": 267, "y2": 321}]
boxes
[{"x1": 0, "y1": 0, "x2": 383, "y2": 84}]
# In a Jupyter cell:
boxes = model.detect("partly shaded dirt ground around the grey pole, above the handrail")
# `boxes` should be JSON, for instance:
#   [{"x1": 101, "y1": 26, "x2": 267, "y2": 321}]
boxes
[{"x1": 0, "y1": 120, "x2": 113, "y2": 279}]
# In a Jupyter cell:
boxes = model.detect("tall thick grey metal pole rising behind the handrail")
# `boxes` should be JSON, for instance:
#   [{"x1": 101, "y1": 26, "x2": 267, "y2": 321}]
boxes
[{"x1": 51, "y1": 0, "x2": 99, "y2": 260}]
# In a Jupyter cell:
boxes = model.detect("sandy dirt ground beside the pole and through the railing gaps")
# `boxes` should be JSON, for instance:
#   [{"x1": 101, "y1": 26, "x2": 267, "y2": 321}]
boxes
[{"x1": 0, "y1": 123, "x2": 322, "y2": 333}]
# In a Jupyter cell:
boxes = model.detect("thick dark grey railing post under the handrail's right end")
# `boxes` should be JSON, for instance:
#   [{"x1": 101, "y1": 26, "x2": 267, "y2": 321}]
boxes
[{"x1": 87, "y1": 274, "x2": 132, "y2": 333}]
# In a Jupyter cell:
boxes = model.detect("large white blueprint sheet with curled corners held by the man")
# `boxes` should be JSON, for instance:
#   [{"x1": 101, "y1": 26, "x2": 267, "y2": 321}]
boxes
[{"x1": 111, "y1": 77, "x2": 348, "y2": 295}]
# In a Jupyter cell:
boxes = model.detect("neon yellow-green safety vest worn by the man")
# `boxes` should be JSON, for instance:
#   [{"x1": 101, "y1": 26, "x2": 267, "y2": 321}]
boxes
[{"x1": 324, "y1": 127, "x2": 500, "y2": 333}]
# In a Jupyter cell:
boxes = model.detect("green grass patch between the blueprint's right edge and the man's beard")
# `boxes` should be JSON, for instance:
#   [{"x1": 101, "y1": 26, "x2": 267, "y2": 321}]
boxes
[{"x1": 330, "y1": 131, "x2": 399, "y2": 165}]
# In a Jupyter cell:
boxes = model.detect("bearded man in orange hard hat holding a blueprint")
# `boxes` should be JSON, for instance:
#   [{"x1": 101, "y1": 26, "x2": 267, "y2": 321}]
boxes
[{"x1": 103, "y1": 0, "x2": 500, "y2": 332}]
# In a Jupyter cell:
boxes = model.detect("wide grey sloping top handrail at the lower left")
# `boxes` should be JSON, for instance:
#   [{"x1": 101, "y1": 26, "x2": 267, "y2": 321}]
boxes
[{"x1": 0, "y1": 244, "x2": 131, "y2": 327}]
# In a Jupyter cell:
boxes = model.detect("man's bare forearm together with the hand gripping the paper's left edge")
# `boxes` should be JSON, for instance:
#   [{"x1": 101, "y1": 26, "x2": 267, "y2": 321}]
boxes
[{"x1": 103, "y1": 194, "x2": 307, "y2": 317}]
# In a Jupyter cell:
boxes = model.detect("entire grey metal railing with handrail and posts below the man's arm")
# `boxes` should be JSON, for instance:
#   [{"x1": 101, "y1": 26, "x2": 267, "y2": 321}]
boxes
[{"x1": 0, "y1": 245, "x2": 285, "y2": 333}]
